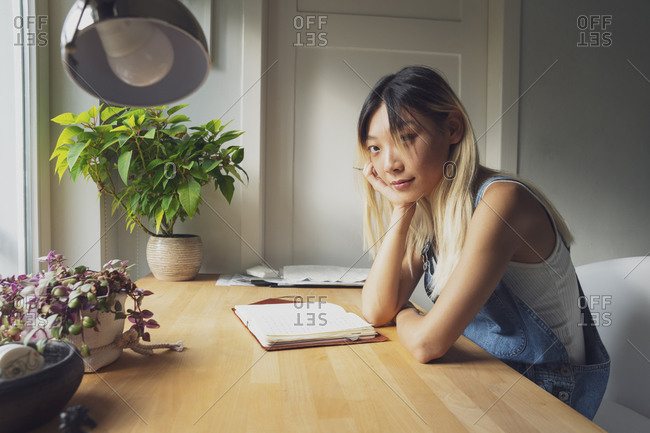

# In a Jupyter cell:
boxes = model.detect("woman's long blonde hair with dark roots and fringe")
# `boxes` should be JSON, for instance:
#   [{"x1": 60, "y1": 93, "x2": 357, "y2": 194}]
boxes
[{"x1": 357, "y1": 66, "x2": 572, "y2": 296}]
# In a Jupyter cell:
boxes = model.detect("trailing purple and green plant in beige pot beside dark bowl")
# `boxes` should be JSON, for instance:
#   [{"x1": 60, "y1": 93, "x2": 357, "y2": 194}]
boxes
[{"x1": 0, "y1": 251, "x2": 159, "y2": 371}]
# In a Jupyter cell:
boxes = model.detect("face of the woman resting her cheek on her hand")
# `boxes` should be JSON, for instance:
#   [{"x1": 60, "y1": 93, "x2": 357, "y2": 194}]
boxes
[{"x1": 366, "y1": 104, "x2": 457, "y2": 202}]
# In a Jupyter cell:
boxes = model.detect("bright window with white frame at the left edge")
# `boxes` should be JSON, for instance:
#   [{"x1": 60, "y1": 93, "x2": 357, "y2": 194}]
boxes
[{"x1": 0, "y1": 0, "x2": 48, "y2": 275}]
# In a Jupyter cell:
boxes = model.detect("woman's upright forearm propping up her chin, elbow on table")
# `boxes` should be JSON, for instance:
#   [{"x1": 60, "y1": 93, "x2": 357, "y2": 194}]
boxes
[{"x1": 361, "y1": 203, "x2": 422, "y2": 326}]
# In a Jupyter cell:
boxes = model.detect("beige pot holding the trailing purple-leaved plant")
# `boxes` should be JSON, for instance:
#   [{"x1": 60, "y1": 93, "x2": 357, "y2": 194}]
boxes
[{"x1": 68, "y1": 293, "x2": 127, "y2": 373}]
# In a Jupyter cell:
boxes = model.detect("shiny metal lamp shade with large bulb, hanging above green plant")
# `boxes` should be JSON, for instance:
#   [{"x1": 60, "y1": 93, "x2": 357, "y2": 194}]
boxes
[{"x1": 61, "y1": 0, "x2": 210, "y2": 107}]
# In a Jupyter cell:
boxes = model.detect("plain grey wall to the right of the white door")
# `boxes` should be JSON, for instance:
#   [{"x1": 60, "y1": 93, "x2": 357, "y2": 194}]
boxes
[{"x1": 519, "y1": 0, "x2": 650, "y2": 265}]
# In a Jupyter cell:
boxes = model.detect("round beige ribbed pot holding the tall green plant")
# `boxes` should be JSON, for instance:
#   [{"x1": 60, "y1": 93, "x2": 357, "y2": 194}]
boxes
[{"x1": 147, "y1": 235, "x2": 203, "y2": 281}]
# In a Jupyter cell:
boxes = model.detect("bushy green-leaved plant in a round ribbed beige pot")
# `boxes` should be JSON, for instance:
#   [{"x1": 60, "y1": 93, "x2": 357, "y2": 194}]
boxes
[{"x1": 50, "y1": 105, "x2": 248, "y2": 281}]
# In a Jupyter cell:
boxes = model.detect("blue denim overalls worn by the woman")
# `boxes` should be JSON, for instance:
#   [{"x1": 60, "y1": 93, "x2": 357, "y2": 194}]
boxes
[{"x1": 422, "y1": 177, "x2": 610, "y2": 419}]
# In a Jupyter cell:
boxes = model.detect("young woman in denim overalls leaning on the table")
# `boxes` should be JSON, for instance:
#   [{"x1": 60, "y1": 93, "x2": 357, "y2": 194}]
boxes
[{"x1": 358, "y1": 67, "x2": 609, "y2": 418}]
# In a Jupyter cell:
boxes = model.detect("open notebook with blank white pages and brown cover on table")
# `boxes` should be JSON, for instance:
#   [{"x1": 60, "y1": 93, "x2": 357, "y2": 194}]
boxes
[{"x1": 233, "y1": 299, "x2": 386, "y2": 350}]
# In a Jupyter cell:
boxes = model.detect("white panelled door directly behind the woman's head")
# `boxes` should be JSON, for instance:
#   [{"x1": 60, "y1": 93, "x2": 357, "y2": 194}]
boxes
[{"x1": 264, "y1": 0, "x2": 512, "y2": 266}]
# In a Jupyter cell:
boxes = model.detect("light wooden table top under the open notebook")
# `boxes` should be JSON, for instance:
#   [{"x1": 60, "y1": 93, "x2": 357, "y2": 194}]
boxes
[{"x1": 31, "y1": 275, "x2": 603, "y2": 433}]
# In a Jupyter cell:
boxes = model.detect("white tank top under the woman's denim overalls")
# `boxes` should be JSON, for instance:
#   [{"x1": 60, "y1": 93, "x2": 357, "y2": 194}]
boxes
[{"x1": 486, "y1": 179, "x2": 585, "y2": 365}]
